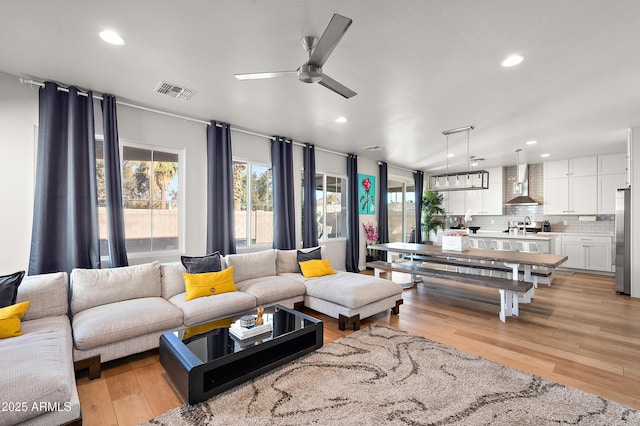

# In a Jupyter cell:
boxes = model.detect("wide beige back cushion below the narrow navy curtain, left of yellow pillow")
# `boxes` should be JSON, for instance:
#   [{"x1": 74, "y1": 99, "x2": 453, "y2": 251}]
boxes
[{"x1": 71, "y1": 262, "x2": 162, "y2": 315}]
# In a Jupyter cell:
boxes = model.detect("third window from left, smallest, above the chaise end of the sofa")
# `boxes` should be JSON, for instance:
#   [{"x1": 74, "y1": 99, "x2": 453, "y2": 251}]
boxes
[{"x1": 303, "y1": 173, "x2": 347, "y2": 240}]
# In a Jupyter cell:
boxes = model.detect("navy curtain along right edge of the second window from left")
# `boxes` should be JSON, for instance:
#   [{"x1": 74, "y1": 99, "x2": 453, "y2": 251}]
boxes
[{"x1": 271, "y1": 136, "x2": 296, "y2": 250}]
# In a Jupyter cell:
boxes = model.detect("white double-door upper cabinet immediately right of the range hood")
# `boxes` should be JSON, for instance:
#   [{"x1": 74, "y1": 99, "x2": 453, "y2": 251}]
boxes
[{"x1": 543, "y1": 157, "x2": 598, "y2": 215}]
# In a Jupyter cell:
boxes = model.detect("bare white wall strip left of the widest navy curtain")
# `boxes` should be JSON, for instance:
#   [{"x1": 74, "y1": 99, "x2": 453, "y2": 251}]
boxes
[{"x1": 0, "y1": 73, "x2": 38, "y2": 275}]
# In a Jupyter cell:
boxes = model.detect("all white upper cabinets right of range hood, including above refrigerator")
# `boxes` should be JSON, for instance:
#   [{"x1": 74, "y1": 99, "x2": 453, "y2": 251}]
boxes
[{"x1": 544, "y1": 154, "x2": 627, "y2": 215}]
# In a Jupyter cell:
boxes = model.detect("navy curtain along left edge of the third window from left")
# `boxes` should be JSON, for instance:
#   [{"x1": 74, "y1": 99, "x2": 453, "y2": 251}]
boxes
[{"x1": 302, "y1": 144, "x2": 318, "y2": 248}]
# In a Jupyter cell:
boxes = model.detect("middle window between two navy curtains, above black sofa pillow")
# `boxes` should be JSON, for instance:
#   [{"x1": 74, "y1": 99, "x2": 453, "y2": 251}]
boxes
[{"x1": 233, "y1": 161, "x2": 273, "y2": 247}]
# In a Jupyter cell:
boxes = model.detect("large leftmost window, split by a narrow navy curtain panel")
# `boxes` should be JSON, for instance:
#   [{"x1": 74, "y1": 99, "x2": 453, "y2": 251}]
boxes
[{"x1": 96, "y1": 140, "x2": 180, "y2": 256}]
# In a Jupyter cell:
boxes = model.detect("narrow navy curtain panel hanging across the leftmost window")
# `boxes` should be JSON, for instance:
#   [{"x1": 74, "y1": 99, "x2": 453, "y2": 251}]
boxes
[{"x1": 102, "y1": 95, "x2": 129, "y2": 268}]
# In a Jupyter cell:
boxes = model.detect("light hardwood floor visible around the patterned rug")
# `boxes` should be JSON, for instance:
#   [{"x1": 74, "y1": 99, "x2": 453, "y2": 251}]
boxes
[{"x1": 77, "y1": 273, "x2": 640, "y2": 425}]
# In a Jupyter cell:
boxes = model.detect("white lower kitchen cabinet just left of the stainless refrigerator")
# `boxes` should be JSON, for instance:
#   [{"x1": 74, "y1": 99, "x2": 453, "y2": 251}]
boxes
[{"x1": 561, "y1": 235, "x2": 612, "y2": 272}]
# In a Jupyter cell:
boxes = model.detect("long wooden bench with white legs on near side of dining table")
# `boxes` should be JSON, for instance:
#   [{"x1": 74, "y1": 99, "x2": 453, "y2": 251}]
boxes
[{"x1": 366, "y1": 260, "x2": 533, "y2": 322}]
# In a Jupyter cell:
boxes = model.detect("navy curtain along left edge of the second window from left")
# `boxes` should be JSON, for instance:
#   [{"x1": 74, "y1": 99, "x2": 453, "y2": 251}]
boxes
[{"x1": 207, "y1": 121, "x2": 236, "y2": 255}]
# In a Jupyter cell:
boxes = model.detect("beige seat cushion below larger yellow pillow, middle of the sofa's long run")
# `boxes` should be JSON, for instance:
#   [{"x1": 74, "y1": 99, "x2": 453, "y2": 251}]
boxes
[{"x1": 169, "y1": 291, "x2": 256, "y2": 327}]
